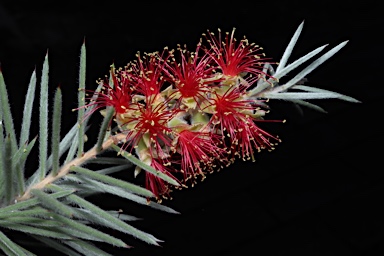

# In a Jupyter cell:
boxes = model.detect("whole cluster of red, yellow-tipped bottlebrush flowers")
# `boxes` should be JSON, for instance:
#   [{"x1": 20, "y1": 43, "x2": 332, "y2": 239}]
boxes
[{"x1": 88, "y1": 30, "x2": 279, "y2": 197}]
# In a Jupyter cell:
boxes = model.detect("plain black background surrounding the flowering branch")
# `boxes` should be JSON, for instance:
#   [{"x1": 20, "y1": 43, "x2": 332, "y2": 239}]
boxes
[{"x1": 0, "y1": 0, "x2": 384, "y2": 256}]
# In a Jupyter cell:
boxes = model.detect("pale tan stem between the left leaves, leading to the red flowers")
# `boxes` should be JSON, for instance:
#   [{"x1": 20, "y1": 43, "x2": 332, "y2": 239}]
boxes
[{"x1": 16, "y1": 133, "x2": 126, "y2": 202}]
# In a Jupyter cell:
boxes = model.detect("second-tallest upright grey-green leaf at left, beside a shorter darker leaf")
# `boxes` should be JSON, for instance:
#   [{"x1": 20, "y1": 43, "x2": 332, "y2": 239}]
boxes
[{"x1": 39, "y1": 53, "x2": 49, "y2": 180}]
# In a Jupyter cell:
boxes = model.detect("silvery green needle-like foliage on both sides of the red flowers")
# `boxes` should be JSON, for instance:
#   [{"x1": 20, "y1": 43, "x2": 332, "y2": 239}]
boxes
[{"x1": 0, "y1": 24, "x2": 358, "y2": 256}]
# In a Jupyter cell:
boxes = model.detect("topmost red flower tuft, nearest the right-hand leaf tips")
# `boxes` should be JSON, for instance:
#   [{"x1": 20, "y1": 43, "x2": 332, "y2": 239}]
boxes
[{"x1": 203, "y1": 29, "x2": 266, "y2": 82}]
